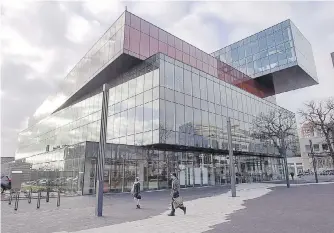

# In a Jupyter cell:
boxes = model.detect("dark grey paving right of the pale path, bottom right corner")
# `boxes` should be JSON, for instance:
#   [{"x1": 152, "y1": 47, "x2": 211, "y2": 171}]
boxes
[{"x1": 206, "y1": 184, "x2": 334, "y2": 233}]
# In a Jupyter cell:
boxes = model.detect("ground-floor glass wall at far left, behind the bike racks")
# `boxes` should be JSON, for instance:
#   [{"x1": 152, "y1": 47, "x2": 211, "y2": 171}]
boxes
[{"x1": 14, "y1": 143, "x2": 85, "y2": 195}]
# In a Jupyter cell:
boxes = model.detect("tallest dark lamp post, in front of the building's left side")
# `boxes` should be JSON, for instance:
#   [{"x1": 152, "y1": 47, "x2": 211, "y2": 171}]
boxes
[{"x1": 95, "y1": 84, "x2": 109, "y2": 217}]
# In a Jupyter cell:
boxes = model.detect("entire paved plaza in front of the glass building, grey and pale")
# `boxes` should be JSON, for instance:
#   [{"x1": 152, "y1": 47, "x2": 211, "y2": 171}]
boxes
[{"x1": 1, "y1": 183, "x2": 334, "y2": 233}]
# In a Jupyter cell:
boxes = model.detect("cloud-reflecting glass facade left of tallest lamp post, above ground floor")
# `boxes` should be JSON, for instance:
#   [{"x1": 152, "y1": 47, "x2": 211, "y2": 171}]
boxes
[{"x1": 15, "y1": 93, "x2": 102, "y2": 159}]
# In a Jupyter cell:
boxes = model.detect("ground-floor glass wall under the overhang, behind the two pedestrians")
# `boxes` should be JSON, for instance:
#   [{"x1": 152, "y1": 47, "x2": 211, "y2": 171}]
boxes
[{"x1": 83, "y1": 142, "x2": 283, "y2": 194}]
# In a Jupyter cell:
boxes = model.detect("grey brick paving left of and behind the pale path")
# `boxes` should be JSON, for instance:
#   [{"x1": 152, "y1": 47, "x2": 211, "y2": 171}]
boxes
[{"x1": 1, "y1": 186, "x2": 228, "y2": 233}]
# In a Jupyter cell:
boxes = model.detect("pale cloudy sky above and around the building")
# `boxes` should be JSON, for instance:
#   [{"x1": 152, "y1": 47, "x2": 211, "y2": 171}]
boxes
[{"x1": 0, "y1": 0, "x2": 334, "y2": 156}]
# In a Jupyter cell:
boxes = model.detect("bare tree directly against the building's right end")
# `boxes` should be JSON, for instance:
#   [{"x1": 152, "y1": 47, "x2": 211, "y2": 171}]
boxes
[{"x1": 252, "y1": 108, "x2": 297, "y2": 188}]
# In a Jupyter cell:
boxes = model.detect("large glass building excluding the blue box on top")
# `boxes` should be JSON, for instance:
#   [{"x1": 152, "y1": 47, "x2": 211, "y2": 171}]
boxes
[{"x1": 11, "y1": 11, "x2": 313, "y2": 194}]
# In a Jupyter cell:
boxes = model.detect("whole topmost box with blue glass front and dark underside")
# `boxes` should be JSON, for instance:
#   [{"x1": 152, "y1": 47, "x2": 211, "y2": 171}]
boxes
[{"x1": 212, "y1": 20, "x2": 318, "y2": 94}]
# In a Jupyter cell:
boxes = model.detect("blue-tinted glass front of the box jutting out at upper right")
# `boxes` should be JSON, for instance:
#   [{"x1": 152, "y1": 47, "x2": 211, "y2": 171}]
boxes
[{"x1": 213, "y1": 20, "x2": 297, "y2": 78}]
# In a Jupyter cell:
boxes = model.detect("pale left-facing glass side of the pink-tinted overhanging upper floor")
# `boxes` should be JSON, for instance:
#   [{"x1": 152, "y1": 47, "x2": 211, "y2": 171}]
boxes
[{"x1": 29, "y1": 13, "x2": 125, "y2": 126}]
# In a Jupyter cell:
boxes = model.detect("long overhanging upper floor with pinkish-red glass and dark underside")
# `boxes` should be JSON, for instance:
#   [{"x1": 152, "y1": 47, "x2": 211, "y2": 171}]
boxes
[{"x1": 29, "y1": 11, "x2": 274, "y2": 125}]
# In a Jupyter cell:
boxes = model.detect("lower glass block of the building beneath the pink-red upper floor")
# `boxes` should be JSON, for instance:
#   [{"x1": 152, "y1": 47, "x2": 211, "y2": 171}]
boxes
[{"x1": 13, "y1": 53, "x2": 294, "y2": 194}]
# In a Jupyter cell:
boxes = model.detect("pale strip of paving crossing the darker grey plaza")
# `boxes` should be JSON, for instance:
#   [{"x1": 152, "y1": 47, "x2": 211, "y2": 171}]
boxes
[{"x1": 54, "y1": 184, "x2": 275, "y2": 233}]
